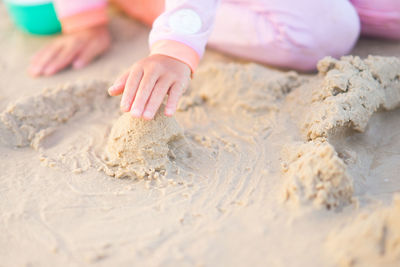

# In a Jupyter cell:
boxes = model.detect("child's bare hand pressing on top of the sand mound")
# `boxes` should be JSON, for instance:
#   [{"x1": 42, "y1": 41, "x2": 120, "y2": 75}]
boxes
[{"x1": 108, "y1": 55, "x2": 191, "y2": 120}]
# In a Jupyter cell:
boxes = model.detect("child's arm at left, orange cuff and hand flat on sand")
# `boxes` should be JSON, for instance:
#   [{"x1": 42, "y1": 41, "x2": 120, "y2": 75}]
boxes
[{"x1": 29, "y1": 0, "x2": 111, "y2": 76}]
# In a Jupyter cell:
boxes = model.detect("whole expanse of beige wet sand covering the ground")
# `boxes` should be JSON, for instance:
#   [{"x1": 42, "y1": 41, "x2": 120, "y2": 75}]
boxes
[{"x1": 0, "y1": 5, "x2": 400, "y2": 266}]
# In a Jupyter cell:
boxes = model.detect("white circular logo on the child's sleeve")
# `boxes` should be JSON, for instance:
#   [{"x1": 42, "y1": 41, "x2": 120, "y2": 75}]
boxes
[{"x1": 168, "y1": 9, "x2": 202, "y2": 34}]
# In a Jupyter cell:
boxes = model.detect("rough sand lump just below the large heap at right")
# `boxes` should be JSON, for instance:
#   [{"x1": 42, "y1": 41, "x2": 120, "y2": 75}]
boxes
[{"x1": 283, "y1": 142, "x2": 353, "y2": 209}]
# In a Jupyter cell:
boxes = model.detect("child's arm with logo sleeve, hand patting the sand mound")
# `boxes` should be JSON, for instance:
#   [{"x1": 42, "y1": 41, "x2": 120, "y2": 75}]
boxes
[{"x1": 109, "y1": 0, "x2": 219, "y2": 119}]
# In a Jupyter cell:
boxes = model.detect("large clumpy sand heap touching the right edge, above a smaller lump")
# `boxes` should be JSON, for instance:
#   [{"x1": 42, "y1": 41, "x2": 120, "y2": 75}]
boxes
[{"x1": 303, "y1": 56, "x2": 400, "y2": 140}]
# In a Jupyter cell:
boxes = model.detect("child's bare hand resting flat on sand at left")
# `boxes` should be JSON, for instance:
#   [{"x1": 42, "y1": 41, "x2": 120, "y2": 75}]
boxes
[{"x1": 28, "y1": 26, "x2": 111, "y2": 76}]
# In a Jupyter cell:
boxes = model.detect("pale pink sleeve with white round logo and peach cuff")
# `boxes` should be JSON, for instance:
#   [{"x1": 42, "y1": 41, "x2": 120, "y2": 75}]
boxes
[{"x1": 149, "y1": 0, "x2": 219, "y2": 72}]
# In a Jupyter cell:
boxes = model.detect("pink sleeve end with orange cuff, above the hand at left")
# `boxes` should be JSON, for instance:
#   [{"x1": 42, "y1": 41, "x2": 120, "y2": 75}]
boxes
[{"x1": 54, "y1": 0, "x2": 108, "y2": 33}]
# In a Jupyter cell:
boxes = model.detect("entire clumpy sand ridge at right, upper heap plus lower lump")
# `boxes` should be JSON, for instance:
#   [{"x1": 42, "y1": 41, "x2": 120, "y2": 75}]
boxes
[{"x1": 282, "y1": 56, "x2": 400, "y2": 209}]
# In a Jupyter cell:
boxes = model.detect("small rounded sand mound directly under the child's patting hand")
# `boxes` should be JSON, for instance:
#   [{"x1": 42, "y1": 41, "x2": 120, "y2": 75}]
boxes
[{"x1": 106, "y1": 108, "x2": 183, "y2": 178}]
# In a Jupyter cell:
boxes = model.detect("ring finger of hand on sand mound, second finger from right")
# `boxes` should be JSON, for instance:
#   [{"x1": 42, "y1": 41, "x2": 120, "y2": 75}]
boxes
[{"x1": 143, "y1": 78, "x2": 172, "y2": 120}]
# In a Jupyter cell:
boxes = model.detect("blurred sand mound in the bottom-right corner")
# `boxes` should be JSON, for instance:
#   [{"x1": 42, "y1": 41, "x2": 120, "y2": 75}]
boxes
[{"x1": 326, "y1": 196, "x2": 400, "y2": 266}]
